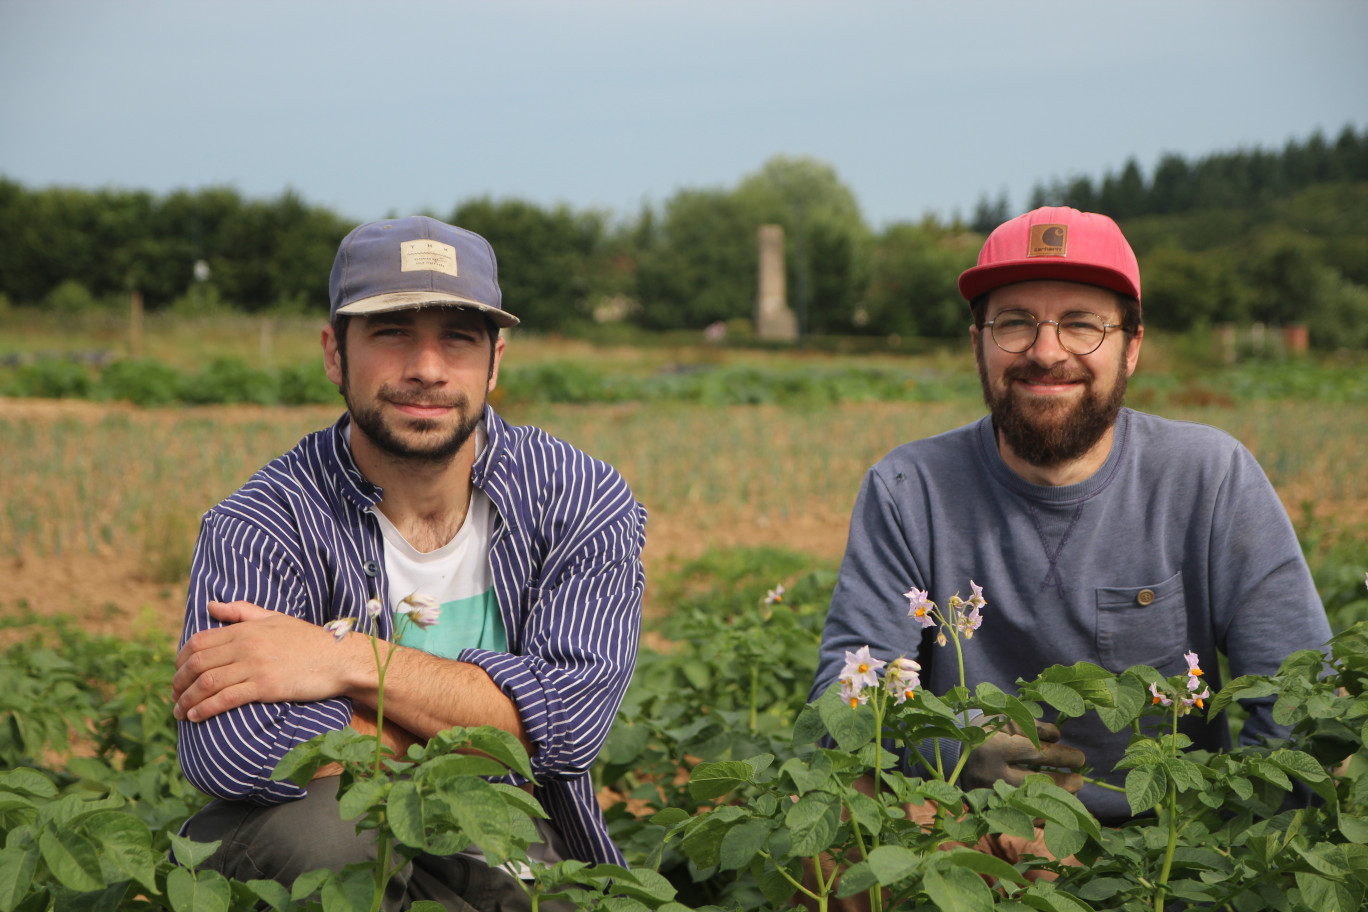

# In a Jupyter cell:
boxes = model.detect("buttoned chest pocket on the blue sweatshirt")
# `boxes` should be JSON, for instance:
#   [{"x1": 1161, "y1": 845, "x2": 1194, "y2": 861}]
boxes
[{"x1": 1096, "y1": 573, "x2": 1187, "y2": 671}]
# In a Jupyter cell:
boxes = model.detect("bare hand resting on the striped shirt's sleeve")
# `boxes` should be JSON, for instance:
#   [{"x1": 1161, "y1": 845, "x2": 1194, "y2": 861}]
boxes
[{"x1": 171, "y1": 602, "x2": 373, "y2": 722}]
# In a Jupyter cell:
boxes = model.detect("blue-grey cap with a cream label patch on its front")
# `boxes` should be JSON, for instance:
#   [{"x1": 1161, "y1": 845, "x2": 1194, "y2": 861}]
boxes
[{"x1": 328, "y1": 216, "x2": 518, "y2": 328}]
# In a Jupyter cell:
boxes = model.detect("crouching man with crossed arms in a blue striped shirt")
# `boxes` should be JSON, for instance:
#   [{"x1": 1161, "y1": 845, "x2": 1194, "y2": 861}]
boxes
[{"x1": 172, "y1": 217, "x2": 646, "y2": 908}]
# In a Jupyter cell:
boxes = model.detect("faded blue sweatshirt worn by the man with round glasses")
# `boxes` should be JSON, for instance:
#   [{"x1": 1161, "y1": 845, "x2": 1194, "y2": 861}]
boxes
[{"x1": 811, "y1": 409, "x2": 1330, "y2": 818}]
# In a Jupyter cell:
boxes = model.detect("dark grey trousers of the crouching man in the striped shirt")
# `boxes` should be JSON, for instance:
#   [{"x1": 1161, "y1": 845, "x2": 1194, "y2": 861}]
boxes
[{"x1": 182, "y1": 777, "x2": 575, "y2": 912}]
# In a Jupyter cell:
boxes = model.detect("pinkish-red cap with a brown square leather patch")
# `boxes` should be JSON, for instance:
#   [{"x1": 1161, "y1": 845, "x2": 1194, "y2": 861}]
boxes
[{"x1": 959, "y1": 206, "x2": 1140, "y2": 301}]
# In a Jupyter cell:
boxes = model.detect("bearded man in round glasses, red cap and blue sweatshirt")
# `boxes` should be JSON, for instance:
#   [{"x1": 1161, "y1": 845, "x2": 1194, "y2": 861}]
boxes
[{"x1": 811, "y1": 208, "x2": 1330, "y2": 822}]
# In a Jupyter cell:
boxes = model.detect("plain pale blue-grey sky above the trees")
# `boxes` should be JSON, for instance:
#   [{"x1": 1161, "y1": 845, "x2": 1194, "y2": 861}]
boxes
[{"x1": 0, "y1": 0, "x2": 1368, "y2": 228}]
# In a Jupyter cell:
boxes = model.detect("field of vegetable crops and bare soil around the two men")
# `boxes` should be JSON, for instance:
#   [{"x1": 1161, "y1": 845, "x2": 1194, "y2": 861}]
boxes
[{"x1": 0, "y1": 317, "x2": 1368, "y2": 912}]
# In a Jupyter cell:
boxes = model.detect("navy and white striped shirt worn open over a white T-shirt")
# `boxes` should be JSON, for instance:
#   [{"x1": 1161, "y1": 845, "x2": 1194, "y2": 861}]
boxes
[{"x1": 179, "y1": 407, "x2": 646, "y2": 863}]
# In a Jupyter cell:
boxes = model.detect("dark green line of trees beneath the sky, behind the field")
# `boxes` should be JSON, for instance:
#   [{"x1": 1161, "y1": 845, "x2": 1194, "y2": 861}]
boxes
[{"x1": 0, "y1": 126, "x2": 1368, "y2": 347}]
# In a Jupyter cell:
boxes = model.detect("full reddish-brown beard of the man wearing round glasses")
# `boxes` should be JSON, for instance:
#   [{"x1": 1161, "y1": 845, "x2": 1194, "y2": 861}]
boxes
[{"x1": 978, "y1": 345, "x2": 1129, "y2": 466}]
